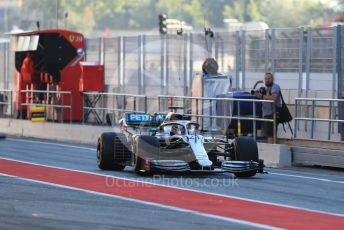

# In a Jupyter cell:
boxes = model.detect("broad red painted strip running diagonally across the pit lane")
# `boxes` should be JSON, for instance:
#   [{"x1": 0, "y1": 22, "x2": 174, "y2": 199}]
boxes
[{"x1": 0, "y1": 158, "x2": 344, "y2": 229}]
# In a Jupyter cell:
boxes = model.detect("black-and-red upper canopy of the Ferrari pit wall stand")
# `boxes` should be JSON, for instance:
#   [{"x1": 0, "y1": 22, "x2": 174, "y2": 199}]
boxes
[{"x1": 11, "y1": 30, "x2": 85, "y2": 82}]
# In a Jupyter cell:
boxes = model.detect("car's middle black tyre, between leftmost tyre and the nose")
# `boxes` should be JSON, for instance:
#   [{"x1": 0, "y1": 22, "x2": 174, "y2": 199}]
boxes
[{"x1": 133, "y1": 136, "x2": 159, "y2": 175}]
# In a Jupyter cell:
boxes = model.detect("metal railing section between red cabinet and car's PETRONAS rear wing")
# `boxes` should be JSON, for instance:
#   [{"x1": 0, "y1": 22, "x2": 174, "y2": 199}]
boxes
[{"x1": 82, "y1": 92, "x2": 148, "y2": 124}]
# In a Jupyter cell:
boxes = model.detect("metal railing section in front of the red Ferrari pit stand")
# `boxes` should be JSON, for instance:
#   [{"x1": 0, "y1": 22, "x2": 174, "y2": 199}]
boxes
[{"x1": 19, "y1": 90, "x2": 73, "y2": 124}]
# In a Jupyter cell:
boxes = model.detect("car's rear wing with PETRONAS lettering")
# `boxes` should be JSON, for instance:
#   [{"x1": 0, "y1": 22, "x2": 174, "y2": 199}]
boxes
[{"x1": 122, "y1": 113, "x2": 166, "y2": 127}]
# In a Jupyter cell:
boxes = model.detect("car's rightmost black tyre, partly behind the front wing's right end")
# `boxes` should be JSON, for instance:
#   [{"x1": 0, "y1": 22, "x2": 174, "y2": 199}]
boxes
[{"x1": 231, "y1": 137, "x2": 258, "y2": 177}]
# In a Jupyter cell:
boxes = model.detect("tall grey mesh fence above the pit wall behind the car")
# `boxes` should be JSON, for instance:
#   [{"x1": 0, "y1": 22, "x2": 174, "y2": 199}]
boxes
[{"x1": 0, "y1": 26, "x2": 343, "y2": 103}]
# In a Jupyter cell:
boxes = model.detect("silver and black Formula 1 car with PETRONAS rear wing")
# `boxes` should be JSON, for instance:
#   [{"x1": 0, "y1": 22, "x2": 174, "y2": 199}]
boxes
[{"x1": 97, "y1": 112, "x2": 264, "y2": 177}]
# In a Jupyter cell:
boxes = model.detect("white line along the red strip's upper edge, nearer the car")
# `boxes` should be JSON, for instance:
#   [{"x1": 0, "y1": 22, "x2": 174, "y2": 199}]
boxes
[{"x1": 0, "y1": 157, "x2": 344, "y2": 217}]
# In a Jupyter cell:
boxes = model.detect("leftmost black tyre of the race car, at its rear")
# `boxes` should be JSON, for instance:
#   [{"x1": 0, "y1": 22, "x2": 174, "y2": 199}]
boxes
[{"x1": 97, "y1": 132, "x2": 130, "y2": 171}]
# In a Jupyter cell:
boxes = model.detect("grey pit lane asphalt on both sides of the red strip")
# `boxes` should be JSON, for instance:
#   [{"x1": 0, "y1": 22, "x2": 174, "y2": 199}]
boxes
[{"x1": 0, "y1": 138, "x2": 344, "y2": 229}]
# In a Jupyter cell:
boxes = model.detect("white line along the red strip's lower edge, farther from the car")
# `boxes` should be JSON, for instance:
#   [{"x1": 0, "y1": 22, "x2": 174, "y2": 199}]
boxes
[{"x1": 0, "y1": 173, "x2": 282, "y2": 230}]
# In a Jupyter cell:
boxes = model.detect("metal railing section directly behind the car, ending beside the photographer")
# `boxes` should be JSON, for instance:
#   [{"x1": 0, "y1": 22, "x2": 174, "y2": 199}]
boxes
[{"x1": 158, "y1": 95, "x2": 277, "y2": 143}]
